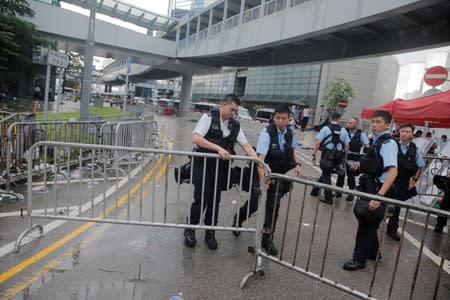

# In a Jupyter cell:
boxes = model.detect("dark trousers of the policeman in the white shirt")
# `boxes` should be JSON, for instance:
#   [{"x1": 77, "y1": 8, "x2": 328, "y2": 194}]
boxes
[{"x1": 190, "y1": 157, "x2": 227, "y2": 225}]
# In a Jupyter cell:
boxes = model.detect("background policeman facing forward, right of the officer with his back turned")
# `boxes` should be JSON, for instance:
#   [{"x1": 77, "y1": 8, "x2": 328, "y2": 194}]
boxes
[{"x1": 336, "y1": 117, "x2": 369, "y2": 201}]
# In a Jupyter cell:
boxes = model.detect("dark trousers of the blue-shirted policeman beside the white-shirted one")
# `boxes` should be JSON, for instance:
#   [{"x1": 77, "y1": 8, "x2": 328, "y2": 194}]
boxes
[{"x1": 238, "y1": 181, "x2": 289, "y2": 233}]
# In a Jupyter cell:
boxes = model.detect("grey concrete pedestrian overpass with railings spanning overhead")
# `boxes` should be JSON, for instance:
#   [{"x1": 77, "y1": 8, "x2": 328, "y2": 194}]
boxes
[{"x1": 30, "y1": 0, "x2": 450, "y2": 106}]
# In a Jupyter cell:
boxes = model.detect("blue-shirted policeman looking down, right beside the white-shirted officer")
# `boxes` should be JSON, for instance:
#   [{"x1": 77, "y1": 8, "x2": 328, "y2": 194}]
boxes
[{"x1": 233, "y1": 104, "x2": 301, "y2": 255}]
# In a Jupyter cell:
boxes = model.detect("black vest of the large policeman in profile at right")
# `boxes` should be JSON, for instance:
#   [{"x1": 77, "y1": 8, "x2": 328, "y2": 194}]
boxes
[{"x1": 359, "y1": 133, "x2": 392, "y2": 177}]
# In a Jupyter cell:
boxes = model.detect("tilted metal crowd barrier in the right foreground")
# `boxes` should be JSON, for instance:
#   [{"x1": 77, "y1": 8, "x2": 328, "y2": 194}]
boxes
[{"x1": 241, "y1": 174, "x2": 450, "y2": 299}]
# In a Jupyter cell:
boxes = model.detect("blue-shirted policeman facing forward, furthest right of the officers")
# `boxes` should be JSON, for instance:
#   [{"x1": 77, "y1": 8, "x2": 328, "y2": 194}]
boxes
[{"x1": 386, "y1": 123, "x2": 425, "y2": 241}]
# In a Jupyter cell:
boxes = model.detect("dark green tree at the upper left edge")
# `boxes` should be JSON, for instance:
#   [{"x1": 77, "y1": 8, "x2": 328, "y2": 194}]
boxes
[{"x1": 0, "y1": 0, "x2": 49, "y2": 92}]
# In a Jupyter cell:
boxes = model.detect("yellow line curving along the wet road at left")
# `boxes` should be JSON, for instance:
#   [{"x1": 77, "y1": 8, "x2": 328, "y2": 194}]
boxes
[{"x1": 0, "y1": 145, "x2": 171, "y2": 283}]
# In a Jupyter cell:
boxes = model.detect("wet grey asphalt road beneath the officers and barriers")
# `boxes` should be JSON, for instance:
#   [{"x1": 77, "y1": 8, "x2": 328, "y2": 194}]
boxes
[{"x1": 0, "y1": 106, "x2": 450, "y2": 299}]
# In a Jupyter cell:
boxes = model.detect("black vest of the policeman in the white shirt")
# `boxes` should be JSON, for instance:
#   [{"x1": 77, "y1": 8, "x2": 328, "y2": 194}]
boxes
[{"x1": 197, "y1": 110, "x2": 241, "y2": 154}]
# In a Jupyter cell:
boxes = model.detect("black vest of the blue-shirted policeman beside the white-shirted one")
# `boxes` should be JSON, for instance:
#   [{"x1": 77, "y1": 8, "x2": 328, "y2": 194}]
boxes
[{"x1": 264, "y1": 124, "x2": 295, "y2": 174}]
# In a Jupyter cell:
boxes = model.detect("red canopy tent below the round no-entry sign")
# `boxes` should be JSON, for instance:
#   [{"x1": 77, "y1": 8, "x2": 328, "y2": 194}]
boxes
[{"x1": 361, "y1": 91, "x2": 450, "y2": 128}]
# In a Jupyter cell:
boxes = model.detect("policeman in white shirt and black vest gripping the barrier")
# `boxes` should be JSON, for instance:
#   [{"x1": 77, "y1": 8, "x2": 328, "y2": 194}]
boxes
[{"x1": 184, "y1": 94, "x2": 256, "y2": 250}]
